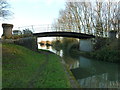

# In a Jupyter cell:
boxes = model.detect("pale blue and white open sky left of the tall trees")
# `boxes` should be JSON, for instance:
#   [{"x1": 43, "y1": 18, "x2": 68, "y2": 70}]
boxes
[{"x1": 0, "y1": 0, "x2": 65, "y2": 36}]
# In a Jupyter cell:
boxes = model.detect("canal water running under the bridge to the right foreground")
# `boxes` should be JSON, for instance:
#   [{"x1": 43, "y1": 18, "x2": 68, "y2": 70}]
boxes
[{"x1": 38, "y1": 44, "x2": 120, "y2": 88}]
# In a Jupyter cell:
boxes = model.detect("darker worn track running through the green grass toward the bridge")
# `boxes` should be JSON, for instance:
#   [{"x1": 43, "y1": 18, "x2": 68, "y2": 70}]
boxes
[{"x1": 28, "y1": 52, "x2": 49, "y2": 88}]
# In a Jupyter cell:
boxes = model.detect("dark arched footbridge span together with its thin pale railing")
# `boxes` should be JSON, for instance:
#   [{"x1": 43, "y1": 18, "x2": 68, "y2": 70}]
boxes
[{"x1": 15, "y1": 24, "x2": 95, "y2": 39}]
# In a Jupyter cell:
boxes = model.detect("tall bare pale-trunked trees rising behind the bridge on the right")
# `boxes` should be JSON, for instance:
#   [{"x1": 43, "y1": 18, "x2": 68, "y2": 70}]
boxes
[{"x1": 54, "y1": 0, "x2": 119, "y2": 37}]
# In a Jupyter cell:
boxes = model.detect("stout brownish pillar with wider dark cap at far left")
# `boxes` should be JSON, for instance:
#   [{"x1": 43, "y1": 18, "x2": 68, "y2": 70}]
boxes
[{"x1": 2, "y1": 23, "x2": 13, "y2": 39}]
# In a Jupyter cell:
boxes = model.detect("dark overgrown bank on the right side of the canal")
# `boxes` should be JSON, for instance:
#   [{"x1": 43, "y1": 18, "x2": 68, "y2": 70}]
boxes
[{"x1": 66, "y1": 38, "x2": 120, "y2": 63}]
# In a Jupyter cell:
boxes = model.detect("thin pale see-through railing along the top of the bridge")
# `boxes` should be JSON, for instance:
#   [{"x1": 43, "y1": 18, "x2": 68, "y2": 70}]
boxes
[{"x1": 14, "y1": 24, "x2": 94, "y2": 35}]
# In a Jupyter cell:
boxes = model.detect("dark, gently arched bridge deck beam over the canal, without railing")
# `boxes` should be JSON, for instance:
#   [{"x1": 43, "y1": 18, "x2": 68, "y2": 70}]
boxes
[{"x1": 33, "y1": 32, "x2": 95, "y2": 39}]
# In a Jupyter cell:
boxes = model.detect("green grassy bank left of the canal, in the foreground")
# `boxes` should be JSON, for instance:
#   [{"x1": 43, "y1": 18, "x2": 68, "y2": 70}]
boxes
[{"x1": 2, "y1": 44, "x2": 71, "y2": 88}]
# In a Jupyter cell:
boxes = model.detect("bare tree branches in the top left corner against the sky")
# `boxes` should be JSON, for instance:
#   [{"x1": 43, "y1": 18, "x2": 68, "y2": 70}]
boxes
[{"x1": 0, "y1": 0, "x2": 12, "y2": 19}]
